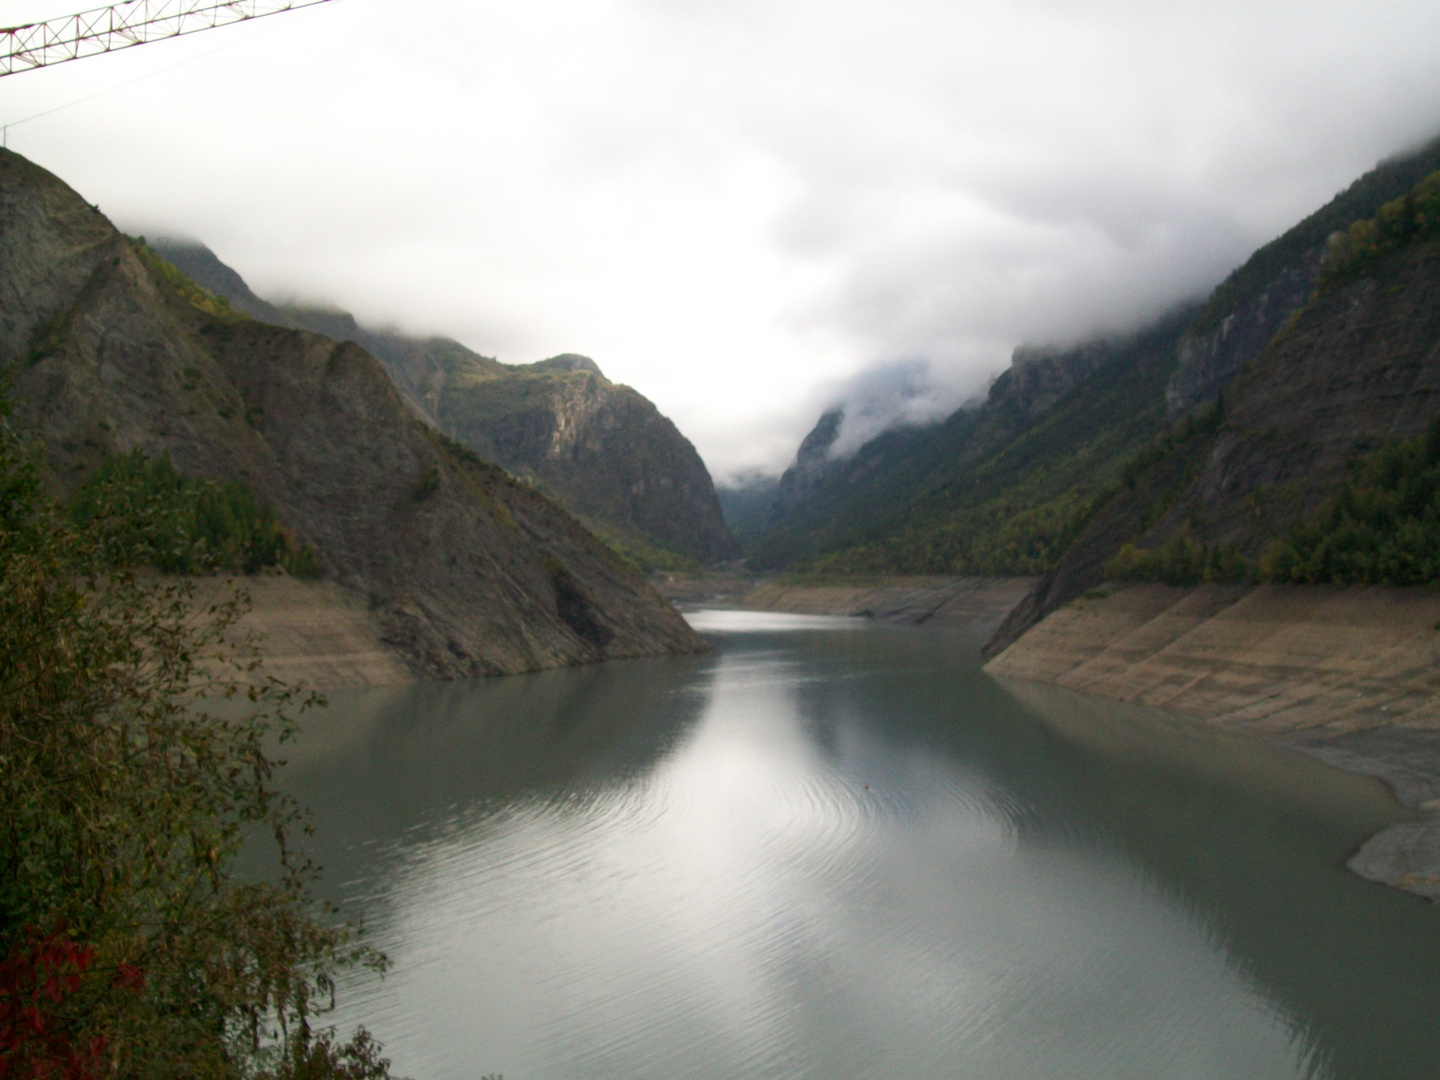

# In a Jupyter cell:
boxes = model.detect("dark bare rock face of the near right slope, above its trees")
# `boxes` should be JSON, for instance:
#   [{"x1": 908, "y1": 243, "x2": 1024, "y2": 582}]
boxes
[{"x1": 986, "y1": 234, "x2": 1440, "y2": 655}]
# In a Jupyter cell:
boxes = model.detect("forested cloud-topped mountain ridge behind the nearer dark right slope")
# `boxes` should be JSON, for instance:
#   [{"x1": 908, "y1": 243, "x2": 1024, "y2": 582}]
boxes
[{"x1": 747, "y1": 141, "x2": 1440, "y2": 587}]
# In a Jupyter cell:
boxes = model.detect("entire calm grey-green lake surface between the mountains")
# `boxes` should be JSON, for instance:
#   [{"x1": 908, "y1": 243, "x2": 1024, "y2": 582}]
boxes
[{"x1": 280, "y1": 612, "x2": 1440, "y2": 1080}]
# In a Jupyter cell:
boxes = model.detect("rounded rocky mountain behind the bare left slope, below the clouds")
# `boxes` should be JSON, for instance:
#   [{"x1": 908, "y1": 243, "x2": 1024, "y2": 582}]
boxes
[{"x1": 147, "y1": 239, "x2": 739, "y2": 562}]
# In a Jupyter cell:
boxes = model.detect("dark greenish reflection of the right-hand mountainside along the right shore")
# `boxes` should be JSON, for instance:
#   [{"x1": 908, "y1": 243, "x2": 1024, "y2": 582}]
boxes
[{"x1": 783, "y1": 634, "x2": 1440, "y2": 1079}]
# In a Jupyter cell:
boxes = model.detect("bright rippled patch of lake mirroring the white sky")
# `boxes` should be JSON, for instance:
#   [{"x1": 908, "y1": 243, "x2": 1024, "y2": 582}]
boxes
[{"x1": 312, "y1": 622, "x2": 1428, "y2": 1080}]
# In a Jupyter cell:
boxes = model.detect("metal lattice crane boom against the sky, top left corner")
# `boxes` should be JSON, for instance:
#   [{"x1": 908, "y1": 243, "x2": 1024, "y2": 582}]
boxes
[{"x1": 0, "y1": 0, "x2": 330, "y2": 78}]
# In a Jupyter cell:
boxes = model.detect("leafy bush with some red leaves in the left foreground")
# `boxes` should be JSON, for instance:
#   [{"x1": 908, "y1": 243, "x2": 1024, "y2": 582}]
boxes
[{"x1": 0, "y1": 408, "x2": 389, "y2": 1080}]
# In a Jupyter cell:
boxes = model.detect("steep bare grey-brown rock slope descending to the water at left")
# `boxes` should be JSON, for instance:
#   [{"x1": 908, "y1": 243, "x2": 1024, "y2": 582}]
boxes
[{"x1": 0, "y1": 151, "x2": 706, "y2": 678}]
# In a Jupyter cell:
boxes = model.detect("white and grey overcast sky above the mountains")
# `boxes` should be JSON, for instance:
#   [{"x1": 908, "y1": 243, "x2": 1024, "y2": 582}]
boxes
[{"x1": 0, "y1": 0, "x2": 1440, "y2": 478}]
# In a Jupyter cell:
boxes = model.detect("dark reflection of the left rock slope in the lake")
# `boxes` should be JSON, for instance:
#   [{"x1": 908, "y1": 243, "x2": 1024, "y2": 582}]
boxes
[{"x1": 284, "y1": 658, "x2": 710, "y2": 887}]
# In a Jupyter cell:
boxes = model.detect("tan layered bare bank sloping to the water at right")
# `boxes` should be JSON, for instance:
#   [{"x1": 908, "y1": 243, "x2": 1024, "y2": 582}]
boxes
[{"x1": 985, "y1": 585, "x2": 1440, "y2": 903}]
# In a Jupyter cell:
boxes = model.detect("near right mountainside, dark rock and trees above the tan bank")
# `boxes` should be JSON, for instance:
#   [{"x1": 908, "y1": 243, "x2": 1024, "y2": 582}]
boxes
[{"x1": 989, "y1": 160, "x2": 1440, "y2": 654}]
